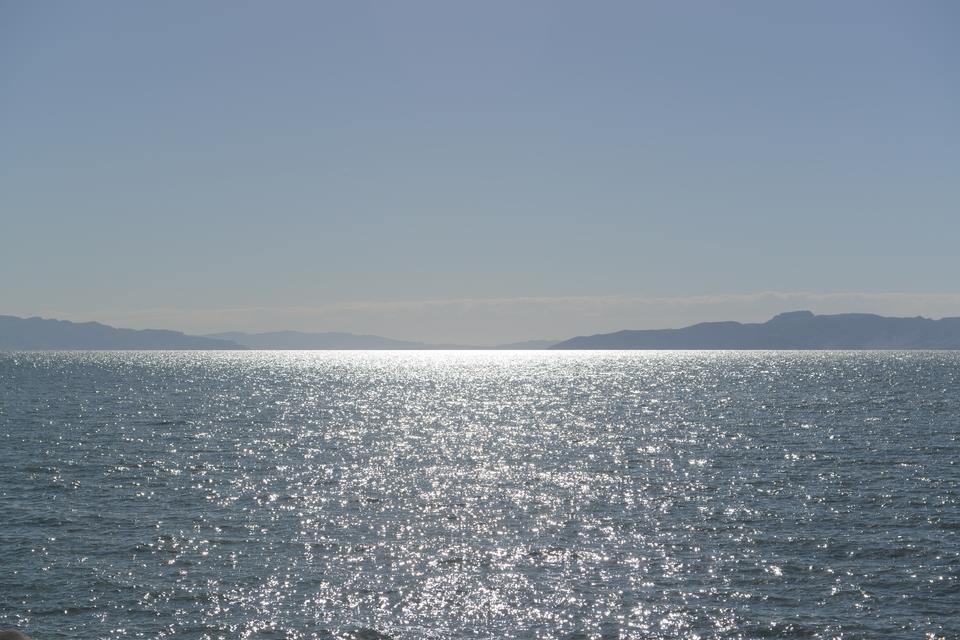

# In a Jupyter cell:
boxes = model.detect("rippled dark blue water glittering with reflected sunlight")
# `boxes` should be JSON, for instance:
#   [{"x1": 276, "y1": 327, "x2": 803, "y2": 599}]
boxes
[{"x1": 0, "y1": 352, "x2": 960, "y2": 640}]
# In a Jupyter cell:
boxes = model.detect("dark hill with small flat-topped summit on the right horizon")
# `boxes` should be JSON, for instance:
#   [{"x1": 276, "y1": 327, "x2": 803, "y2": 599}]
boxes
[{"x1": 551, "y1": 311, "x2": 960, "y2": 349}]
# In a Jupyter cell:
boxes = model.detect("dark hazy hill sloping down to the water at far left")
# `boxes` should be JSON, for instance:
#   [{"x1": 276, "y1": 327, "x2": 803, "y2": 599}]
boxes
[{"x1": 0, "y1": 316, "x2": 243, "y2": 351}]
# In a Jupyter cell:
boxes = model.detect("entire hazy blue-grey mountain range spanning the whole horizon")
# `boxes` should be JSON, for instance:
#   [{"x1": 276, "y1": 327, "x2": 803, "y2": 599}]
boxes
[{"x1": 0, "y1": 311, "x2": 960, "y2": 351}]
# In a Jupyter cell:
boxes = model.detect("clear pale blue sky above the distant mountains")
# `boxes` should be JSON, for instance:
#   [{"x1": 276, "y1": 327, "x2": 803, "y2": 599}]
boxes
[{"x1": 0, "y1": 0, "x2": 960, "y2": 344}]
